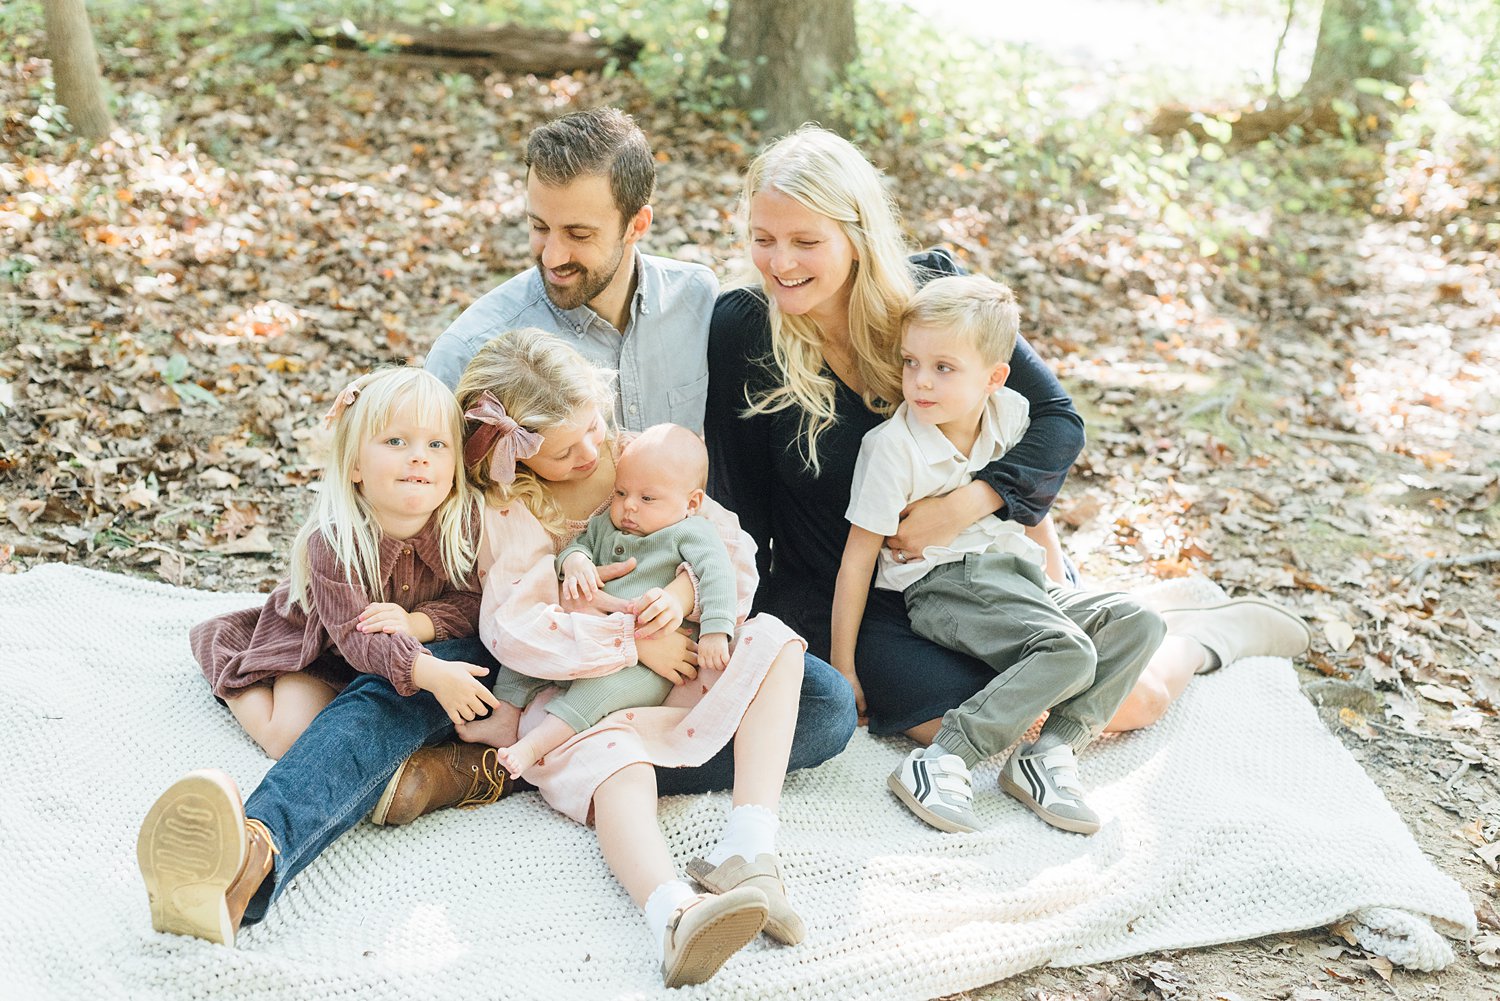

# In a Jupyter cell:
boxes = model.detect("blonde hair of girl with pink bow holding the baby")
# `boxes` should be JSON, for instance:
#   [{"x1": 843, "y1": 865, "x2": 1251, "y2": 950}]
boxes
[{"x1": 458, "y1": 327, "x2": 615, "y2": 539}]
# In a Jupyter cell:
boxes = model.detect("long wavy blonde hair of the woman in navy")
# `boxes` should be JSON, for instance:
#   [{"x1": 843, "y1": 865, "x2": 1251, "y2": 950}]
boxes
[{"x1": 740, "y1": 126, "x2": 917, "y2": 473}]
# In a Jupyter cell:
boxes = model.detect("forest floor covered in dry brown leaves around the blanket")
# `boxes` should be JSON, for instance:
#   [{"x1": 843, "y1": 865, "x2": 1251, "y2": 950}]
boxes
[{"x1": 0, "y1": 17, "x2": 1500, "y2": 1001}]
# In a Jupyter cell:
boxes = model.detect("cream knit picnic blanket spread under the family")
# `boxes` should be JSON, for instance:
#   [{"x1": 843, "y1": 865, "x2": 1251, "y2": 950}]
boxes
[{"x1": 0, "y1": 566, "x2": 1475, "y2": 1001}]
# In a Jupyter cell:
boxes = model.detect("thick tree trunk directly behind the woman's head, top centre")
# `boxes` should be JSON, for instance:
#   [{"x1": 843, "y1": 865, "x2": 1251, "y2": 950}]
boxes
[{"x1": 723, "y1": 0, "x2": 858, "y2": 135}]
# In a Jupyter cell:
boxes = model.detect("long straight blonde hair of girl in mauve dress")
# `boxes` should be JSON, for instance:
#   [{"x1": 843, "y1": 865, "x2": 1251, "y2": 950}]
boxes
[{"x1": 291, "y1": 368, "x2": 482, "y2": 609}]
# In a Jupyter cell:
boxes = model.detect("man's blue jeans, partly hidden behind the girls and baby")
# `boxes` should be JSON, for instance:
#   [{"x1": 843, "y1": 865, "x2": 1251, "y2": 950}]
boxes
[{"x1": 245, "y1": 638, "x2": 855, "y2": 924}]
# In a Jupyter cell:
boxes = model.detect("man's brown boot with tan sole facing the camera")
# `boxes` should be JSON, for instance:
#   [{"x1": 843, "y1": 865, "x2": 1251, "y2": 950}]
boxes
[{"x1": 135, "y1": 770, "x2": 278, "y2": 945}]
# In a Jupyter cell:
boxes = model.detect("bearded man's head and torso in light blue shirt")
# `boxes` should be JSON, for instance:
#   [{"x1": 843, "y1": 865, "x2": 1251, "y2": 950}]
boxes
[{"x1": 426, "y1": 108, "x2": 719, "y2": 434}]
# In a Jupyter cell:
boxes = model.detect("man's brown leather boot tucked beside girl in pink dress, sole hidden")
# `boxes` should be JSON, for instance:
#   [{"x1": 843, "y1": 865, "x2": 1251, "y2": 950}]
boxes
[{"x1": 371, "y1": 741, "x2": 512, "y2": 827}]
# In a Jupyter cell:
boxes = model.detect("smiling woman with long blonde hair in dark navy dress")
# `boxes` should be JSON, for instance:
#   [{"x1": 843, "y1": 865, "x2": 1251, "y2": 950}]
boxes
[{"x1": 705, "y1": 128, "x2": 1308, "y2": 759}]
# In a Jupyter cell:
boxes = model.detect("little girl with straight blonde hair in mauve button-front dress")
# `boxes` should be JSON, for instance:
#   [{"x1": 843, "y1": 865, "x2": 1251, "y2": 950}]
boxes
[{"x1": 191, "y1": 368, "x2": 494, "y2": 758}]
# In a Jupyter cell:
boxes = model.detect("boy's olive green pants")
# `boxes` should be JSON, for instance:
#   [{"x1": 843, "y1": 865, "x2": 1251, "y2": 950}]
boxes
[{"x1": 905, "y1": 552, "x2": 1167, "y2": 767}]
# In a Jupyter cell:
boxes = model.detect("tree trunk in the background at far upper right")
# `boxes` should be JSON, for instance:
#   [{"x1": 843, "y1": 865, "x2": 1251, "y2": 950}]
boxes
[{"x1": 1296, "y1": 0, "x2": 1418, "y2": 110}]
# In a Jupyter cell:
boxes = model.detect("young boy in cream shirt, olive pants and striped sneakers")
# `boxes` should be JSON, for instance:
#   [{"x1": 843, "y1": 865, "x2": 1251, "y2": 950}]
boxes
[{"x1": 833, "y1": 276, "x2": 1166, "y2": 834}]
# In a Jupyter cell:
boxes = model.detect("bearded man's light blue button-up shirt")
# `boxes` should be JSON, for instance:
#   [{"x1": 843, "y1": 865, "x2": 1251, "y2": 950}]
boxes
[{"x1": 426, "y1": 251, "x2": 719, "y2": 434}]
